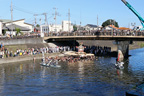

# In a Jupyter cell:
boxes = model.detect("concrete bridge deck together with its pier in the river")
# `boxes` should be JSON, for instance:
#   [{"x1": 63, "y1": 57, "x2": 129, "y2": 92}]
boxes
[{"x1": 44, "y1": 35, "x2": 144, "y2": 58}]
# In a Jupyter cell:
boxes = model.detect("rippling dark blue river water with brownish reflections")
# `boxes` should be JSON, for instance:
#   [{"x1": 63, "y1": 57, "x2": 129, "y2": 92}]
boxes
[{"x1": 0, "y1": 48, "x2": 144, "y2": 96}]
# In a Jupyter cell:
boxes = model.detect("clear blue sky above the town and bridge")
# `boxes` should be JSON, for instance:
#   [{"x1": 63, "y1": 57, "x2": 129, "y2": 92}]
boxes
[{"x1": 0, "y1": 0, "x2": 144, "y2": 27}]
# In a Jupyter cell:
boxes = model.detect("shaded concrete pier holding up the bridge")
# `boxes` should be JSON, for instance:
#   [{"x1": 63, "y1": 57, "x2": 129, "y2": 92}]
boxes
[{"x1": 117, "y1": 41, "x2": 130, "y2": 58}]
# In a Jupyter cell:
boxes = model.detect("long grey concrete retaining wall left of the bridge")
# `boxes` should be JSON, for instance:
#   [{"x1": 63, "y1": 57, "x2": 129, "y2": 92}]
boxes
[{"x1": 0, "y1": 37, "x2": 43, "y2": 45}]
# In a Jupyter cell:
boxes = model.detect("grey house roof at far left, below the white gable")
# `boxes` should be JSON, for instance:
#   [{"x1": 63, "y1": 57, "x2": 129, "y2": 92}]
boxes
[{"x1": 3, "y1": 24, "x2": 30, "y2": 31}]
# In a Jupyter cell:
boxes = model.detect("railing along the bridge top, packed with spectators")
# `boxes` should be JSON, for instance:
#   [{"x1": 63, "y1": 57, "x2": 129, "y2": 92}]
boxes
[{"x1": 45, "y1": 30, "x2": 144, "y2": 36}]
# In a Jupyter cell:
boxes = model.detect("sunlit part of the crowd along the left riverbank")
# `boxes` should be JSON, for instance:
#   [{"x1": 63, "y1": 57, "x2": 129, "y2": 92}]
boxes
[{"x1": 2, "y1": 46, "x2": 70, "y2": 58}]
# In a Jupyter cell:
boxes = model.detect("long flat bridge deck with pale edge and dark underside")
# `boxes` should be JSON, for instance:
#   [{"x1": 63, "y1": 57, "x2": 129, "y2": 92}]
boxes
[{"x1": 44, "y1": 36, "x2": 144, "y2": 41}]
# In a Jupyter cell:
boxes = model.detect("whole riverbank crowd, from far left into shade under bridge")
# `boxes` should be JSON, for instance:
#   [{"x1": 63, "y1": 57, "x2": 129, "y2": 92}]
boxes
[{"x1": 0, "y1": 44, "x2": 111, "y2": 58}]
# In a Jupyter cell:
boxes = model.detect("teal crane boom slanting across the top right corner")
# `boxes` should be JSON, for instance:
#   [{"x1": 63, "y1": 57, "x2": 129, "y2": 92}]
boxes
[{"x1": 121, "y1": 0, "x2": 144, "y2": 30}]
